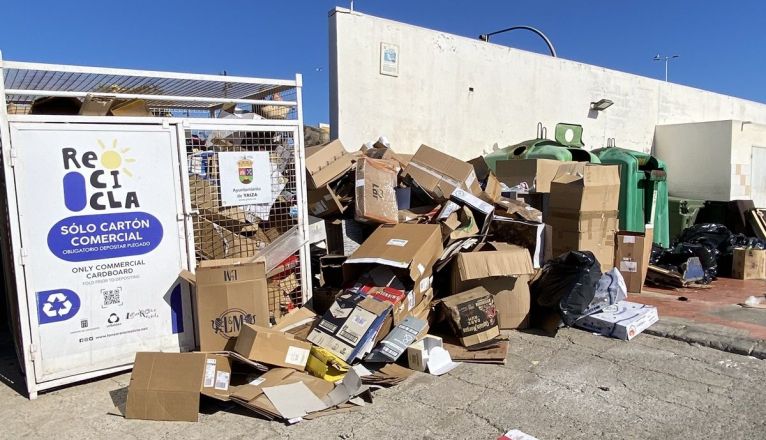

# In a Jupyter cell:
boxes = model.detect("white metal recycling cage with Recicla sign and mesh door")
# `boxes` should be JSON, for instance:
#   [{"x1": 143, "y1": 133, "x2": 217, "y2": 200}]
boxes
[{"x1": 0, "y1": 56, "x2": 311, "y2": 398}]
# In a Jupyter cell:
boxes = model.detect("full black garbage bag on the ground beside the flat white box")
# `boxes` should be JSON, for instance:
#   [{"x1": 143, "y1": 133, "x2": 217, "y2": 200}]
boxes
[{"x1": 529, "y1": 251, "x2": 601, "y2": 326}]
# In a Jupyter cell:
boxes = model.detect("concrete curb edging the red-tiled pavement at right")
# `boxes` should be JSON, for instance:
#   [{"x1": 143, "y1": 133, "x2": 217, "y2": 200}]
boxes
[{"x1": 644, "y1": 318, "x2": 766, "y2": 359}]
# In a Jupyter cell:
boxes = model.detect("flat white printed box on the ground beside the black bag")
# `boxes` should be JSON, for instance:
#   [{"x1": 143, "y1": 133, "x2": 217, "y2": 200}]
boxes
[{"x1": 575, "y1": 301, "x2": 659, "y2": 341}]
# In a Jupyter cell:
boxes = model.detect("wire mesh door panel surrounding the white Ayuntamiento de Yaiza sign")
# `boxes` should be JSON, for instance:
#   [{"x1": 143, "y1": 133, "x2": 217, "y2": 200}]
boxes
[{"x1": 186, "y1": 127, "x2": 303, "y2": 319}]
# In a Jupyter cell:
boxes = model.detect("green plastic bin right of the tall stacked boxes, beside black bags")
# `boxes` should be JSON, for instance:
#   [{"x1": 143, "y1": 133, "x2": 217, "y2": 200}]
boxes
[{"x1": 593, "y1": 146, "x2": 670, "y2": 247}]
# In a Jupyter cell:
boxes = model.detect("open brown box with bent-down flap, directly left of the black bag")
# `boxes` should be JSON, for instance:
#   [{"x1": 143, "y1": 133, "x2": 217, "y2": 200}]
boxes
[{"x1": 452, "y1": 243, "x2": 534, "y2": 330}]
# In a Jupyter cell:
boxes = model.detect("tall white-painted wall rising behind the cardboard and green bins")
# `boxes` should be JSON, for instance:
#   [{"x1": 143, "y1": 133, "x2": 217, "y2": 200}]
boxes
[{"x1": 330, "y1": 9, "x2": 766, "y2": 159}]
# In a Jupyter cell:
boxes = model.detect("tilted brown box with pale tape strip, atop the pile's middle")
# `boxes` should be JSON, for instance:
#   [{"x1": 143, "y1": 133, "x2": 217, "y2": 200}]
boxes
[{"x1": 404, "y1": 145, "x2": 481, "y2": 201}]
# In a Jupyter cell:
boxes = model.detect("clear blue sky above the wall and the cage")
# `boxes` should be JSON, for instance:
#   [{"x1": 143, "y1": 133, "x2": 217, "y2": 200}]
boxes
[{"x1": 0, "y1": 0, "x2": 766, "y2": 124}]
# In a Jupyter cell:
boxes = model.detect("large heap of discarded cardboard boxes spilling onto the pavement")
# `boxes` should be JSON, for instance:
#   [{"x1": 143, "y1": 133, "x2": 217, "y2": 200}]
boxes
[{"x1": 126, "y1": 140, "x2": 656, "y2": 422}]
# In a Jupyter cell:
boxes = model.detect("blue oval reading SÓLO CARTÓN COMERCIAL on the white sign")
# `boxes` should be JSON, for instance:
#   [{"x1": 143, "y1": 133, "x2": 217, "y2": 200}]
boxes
[{"x1": 48, "y1": 211, "x2": 162, "y2": 261}]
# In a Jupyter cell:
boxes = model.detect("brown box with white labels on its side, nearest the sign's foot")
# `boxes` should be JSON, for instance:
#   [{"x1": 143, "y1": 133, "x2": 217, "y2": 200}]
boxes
[{"x1": 125, "y1": 352, "x2": 232, "y2": 422}]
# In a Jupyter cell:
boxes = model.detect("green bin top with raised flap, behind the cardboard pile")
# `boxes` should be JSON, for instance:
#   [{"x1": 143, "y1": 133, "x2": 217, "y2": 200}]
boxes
[{"x1": 484, "y1": 123, "x2": 600, "y2": 171}]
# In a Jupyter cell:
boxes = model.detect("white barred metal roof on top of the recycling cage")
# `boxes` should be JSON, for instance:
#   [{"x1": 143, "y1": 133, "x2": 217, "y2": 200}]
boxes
[{"x1": 0, "y1": 54, "x2": 301, "y2": 111}]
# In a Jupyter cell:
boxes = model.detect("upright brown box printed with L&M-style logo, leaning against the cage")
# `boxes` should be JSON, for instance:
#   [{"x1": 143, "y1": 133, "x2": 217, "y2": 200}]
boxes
[{"x1": 195, "y1": 259, "x2": 270, "y2": 351}]
